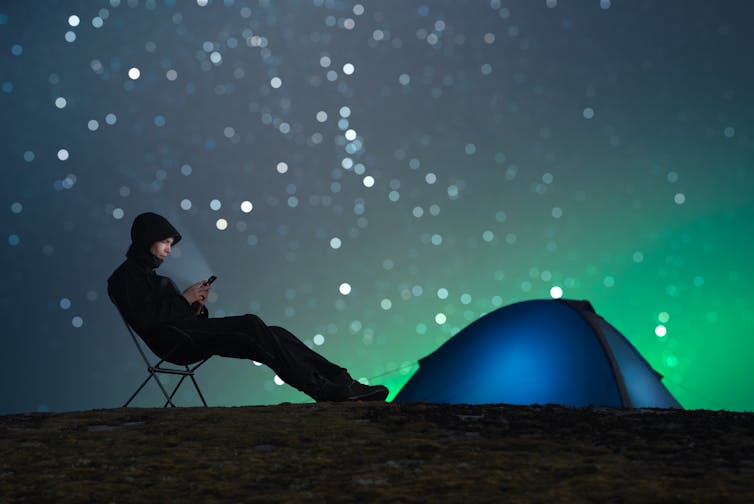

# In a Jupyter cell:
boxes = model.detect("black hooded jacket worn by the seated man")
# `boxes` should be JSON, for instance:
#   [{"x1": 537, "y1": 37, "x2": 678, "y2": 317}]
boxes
[{"x1": 107, "y1": 212, "x2": 207, "y2": 340}]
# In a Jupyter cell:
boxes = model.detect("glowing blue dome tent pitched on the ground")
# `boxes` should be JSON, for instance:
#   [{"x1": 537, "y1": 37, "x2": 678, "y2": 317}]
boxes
[{"x1": 394, "y1": 299, "x2": 681, "y2": 408}]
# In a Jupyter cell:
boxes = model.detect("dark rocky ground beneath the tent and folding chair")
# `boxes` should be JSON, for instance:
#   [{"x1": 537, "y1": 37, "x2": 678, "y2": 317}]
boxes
[{"x1": 0, "y1": 403, "x2": 754, "y2": 503}]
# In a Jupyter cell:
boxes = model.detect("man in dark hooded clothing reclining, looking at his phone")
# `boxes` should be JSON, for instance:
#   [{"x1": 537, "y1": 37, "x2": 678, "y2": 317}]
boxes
[{"x1": 107, "y1": 212, "x2": 388, "y2": 401}]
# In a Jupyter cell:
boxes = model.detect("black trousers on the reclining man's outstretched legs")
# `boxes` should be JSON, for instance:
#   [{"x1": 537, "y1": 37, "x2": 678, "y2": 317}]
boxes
[{"x1": 149, "y1": 315, "x2": 351, "y2": 400}]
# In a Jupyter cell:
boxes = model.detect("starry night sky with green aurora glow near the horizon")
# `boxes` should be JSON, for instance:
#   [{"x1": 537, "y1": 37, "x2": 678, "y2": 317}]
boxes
[{"x1": 0, "y1": 0, "x2": 754, "y2": 413}]
